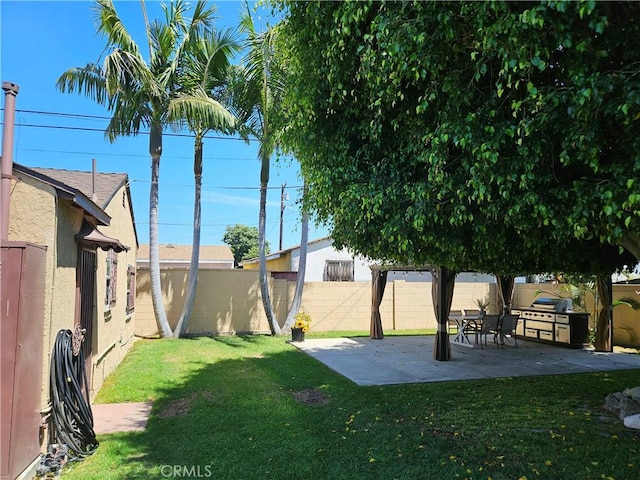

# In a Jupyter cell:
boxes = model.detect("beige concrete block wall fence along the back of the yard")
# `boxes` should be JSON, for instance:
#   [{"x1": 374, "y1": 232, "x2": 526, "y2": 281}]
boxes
[{"x1": 135, "y1": 268, "x2": 640, "y2": 345}]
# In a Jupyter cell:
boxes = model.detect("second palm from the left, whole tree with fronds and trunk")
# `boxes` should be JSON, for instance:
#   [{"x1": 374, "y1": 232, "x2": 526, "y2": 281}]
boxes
[{"x1": 170, "y1": 30, "x2": 240, "y2": 337}]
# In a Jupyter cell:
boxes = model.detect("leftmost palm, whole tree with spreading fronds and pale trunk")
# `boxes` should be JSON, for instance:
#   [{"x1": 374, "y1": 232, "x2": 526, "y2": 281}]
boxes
[{"x1": 57, "y1": 0, "x2": 233, "y2": 337}]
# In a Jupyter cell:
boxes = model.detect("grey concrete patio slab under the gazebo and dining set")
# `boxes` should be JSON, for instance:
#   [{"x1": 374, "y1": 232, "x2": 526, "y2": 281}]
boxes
[{"x1": 292, "y1": 336, "x2": 640, "y2": 385}]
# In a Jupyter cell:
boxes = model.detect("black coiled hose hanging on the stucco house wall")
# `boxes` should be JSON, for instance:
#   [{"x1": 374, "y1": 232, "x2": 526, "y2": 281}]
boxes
[{"x1": 49, "y1": 330, "x2": 98, "y2": 458}]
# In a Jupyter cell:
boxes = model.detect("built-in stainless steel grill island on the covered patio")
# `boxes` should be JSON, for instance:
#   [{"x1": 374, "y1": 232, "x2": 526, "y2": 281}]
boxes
[{"x1": 512, "y1": 298, "x2": 589, "y2": 348}]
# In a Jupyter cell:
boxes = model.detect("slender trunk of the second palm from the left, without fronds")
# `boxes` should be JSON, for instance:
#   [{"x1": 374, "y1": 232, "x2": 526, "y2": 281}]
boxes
[{"x1": 174, "y1": 135, "x2": 202, "y2": 338}]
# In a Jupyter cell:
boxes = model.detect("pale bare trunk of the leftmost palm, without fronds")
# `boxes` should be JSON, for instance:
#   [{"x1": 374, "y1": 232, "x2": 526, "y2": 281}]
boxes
[{"x1": 149, "y1": 125, "x2": 172, "y2": 337}]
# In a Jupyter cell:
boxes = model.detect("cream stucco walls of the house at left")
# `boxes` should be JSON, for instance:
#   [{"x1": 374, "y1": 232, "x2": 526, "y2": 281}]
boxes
[{"x1": 8, "y1": 166, "x2": 137, "y2": 411}]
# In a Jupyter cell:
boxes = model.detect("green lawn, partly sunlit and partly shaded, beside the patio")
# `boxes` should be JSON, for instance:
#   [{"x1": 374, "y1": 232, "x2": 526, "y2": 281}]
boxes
[{"x1": 63, "y1": 335, "x2": 640, "y2": 480}]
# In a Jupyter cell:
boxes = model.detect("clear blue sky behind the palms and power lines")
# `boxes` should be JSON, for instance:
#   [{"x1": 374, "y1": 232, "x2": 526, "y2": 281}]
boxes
[{"x1": 0, "y1": 0, "x2": 327, "y2": 251}]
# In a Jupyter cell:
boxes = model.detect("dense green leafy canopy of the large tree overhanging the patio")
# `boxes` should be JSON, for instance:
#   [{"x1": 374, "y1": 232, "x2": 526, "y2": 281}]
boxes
[{"x1": 279, "y1": 1, "x2": 640, "y2": 274}]
